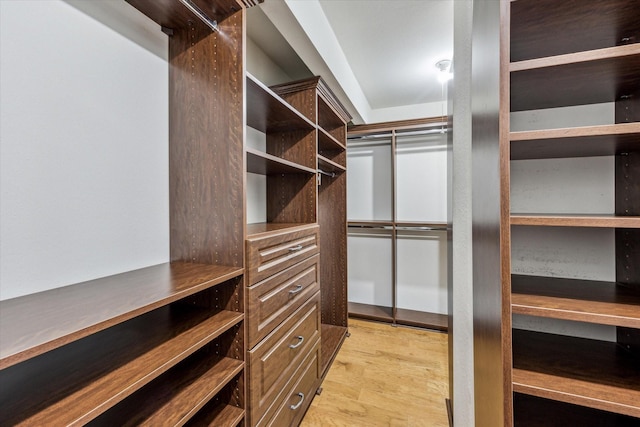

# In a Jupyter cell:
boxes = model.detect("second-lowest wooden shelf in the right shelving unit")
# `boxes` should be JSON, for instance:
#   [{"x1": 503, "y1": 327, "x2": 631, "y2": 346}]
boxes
[{"x1": 511, "y1": 275, "x2": 640, "y2": 329}]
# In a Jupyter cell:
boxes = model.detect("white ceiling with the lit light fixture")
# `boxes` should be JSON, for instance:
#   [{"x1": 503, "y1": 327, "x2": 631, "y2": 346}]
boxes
[{"x1": 248, "y1": 0, "x2": 454, "y2": 123}]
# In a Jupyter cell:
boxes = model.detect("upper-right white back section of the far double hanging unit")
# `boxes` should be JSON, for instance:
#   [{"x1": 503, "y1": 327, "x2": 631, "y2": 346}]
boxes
[{"x1": 396, "y1": 133, "x2": 447, "y2": 222}]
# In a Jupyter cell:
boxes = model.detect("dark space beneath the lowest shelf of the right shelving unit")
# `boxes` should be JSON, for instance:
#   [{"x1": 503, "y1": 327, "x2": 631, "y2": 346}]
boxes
[{"x1": 513, "y1": 393, "x2": 638, "y2": 427}]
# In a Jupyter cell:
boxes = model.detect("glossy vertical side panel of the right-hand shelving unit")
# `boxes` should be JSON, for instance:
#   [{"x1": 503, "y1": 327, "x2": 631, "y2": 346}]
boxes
[{"x1": 471, "y1": 1, "x2": 512, "y2": 427}]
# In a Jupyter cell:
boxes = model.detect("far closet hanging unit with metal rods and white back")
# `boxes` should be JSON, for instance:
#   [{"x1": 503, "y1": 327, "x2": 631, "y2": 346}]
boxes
[{"x1": 347, "y1": 118, "x2": 447, "y2": 330}]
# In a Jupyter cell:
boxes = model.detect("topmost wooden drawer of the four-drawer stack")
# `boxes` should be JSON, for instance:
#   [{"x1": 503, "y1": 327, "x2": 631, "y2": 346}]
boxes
[{"x1": 246, "y1": 224, "x2": 319, "y2": 286}]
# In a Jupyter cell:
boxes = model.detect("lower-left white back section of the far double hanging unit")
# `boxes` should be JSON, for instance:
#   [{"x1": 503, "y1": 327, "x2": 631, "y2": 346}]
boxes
[{"x1": 347, "y1": 229, "x2": 393, "y2": 307}]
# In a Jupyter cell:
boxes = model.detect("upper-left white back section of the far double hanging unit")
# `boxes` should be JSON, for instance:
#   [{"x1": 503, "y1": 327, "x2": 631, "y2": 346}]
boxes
[{"x1": 347, "y1": 138, "x2": 393, "y2": 221}]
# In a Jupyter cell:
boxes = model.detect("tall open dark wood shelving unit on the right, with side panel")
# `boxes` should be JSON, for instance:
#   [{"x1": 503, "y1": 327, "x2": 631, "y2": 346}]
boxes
[{"x1": 472, "y1": 0, "x2": 640, "y2": 426}]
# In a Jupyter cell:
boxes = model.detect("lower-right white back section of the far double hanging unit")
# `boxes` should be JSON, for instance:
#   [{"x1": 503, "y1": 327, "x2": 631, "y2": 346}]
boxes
[{"x1": 396, "y1": 231, "x2": 447, "y2": 314}]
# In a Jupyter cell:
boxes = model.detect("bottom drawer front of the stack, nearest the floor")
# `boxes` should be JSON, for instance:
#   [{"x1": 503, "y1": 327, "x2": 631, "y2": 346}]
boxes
[{"x1": 259, "y1": 343, "x2": 321, "y2": 427}]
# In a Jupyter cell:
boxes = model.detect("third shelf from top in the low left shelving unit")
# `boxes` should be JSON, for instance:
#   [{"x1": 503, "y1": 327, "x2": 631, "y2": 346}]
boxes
[{"x1": 96, "y1": 351, "x2": 244, "y2": 426}]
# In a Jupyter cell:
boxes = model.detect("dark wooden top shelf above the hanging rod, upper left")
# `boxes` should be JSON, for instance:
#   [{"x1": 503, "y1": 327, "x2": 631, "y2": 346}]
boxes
[{"x1": 126, "y1": 0, "x2": 254, "y2": 31}]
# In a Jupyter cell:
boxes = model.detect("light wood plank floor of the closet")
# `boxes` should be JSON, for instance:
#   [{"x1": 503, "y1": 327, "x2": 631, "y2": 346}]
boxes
[{"x1": 301, "y1": 319, "x2": 449, "y2": 427}]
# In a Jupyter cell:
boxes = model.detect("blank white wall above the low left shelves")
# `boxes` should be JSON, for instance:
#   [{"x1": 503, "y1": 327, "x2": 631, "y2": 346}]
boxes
[{"x1": 0, "y1": 0, "x2": 169, "y2": 299}]
